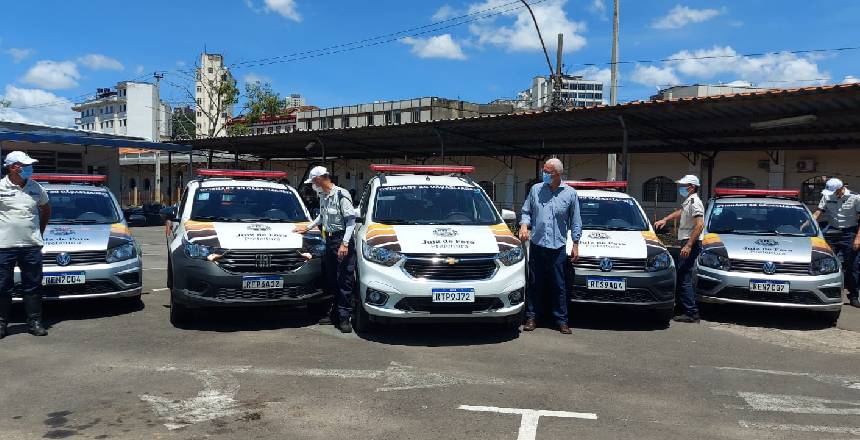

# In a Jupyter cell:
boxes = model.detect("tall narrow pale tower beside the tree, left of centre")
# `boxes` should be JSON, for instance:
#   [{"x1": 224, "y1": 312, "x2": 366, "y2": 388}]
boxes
[{"x1": 194, "y1": 52, "x2": 235, "y2": 138}]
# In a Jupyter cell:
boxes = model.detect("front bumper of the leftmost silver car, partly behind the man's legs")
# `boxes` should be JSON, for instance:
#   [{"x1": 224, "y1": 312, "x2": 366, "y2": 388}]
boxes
[{"x1": 12, "y1": 257, "x2": 143, "y2": 301}]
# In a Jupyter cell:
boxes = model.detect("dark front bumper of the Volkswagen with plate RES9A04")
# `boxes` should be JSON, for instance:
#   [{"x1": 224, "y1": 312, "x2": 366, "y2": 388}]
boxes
[{"x1": 567, "y1": 266, "x2": 676, "y2": 310}]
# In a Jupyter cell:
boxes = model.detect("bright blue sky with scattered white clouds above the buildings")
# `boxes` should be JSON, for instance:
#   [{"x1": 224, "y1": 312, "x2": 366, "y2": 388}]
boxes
[{"x1": 0, "y1": 0, "x2": 860, "y2": 126}]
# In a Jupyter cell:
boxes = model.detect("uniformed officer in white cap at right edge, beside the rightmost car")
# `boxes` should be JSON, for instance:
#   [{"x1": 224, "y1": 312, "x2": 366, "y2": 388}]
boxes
[{"x1": 812, "y1": 177, "x2": 860, "y2": 307}]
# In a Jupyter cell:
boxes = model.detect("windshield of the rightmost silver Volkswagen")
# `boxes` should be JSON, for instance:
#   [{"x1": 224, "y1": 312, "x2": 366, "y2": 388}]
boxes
[{"x1": 708, "y1": 202, "x2": 818, "y2": 237}]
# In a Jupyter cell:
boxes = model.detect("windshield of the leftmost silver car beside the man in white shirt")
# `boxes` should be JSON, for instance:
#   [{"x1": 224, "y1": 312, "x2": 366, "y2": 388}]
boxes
[{"x1": 47, "y1": 189, "x2": 122, "y2": 224}]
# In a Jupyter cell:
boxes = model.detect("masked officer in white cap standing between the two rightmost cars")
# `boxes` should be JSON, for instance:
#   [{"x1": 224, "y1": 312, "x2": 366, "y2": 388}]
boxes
[{"x1": 654, "y1": 174, "x2": 705, "y2": 323}]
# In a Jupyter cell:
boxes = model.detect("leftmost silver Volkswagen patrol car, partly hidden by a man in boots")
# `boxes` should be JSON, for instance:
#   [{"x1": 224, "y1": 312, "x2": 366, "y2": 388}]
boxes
[{"x1": 12, "y1": 174, "x2": 142, "y2": 301}]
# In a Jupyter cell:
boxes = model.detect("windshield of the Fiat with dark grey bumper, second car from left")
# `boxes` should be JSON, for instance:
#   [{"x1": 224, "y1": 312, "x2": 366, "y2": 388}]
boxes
[{"x1": 191, "y1": 186, "x2": 308, "y2": 223}]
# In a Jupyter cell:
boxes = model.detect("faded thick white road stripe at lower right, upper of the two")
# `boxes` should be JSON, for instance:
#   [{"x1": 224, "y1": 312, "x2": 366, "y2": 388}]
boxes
[{"x1": 738, "y1": 392, "x2": 860, "y2": 416}]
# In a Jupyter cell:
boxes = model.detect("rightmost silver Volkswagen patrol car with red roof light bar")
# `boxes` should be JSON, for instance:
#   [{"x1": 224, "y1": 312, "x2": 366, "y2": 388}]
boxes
[{"x1": 694, "y1": 189, "x2": 843, "y2": 323}]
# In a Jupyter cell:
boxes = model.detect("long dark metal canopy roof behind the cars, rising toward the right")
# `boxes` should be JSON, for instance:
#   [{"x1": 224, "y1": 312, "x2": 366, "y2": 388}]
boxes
[{"x1": 190, "y1": 84, "x2": 860, "y2": 159}]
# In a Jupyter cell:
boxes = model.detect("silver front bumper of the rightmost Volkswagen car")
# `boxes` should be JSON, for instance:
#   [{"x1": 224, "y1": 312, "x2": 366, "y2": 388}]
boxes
[{"x1": 693, "y1": 265, "x2": 843, "y2": 311}]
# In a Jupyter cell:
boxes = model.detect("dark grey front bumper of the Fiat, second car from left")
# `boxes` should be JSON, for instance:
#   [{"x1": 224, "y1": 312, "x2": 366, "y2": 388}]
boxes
[{"x1": 170, "y1": 249, "x2": 330, "y2": 308}]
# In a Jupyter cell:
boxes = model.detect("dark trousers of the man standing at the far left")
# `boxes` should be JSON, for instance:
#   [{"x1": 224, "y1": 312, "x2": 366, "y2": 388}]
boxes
[{"x1": 0, "y1": 246, "x2": 42, "y2": 324}]
